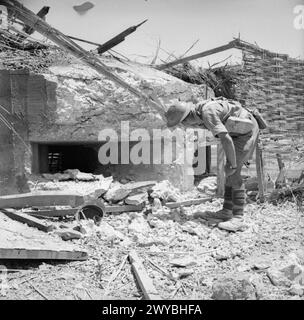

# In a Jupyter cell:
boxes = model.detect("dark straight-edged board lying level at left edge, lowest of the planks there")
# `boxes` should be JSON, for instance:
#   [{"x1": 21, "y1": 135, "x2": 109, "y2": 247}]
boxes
[{"x1": 0, "y1": 248, "x2": 88, "y2": 260}]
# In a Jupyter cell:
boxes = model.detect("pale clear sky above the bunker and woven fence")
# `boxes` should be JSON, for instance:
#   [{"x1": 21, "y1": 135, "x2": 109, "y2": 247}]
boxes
[{"x1": 21, "y1": 0, "x2": 304, "y2": 64}]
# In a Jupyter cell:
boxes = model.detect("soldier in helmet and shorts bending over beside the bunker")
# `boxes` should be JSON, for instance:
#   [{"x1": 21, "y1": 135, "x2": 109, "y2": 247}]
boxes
[{"x1": 165, "y1": 98, "x2": 259, "y2": 232}]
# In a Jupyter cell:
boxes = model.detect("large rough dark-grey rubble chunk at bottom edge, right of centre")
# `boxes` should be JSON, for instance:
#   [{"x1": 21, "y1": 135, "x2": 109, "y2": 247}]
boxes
[{"x1": 211, "y1": 273, "x2": 256, "y2": 300}]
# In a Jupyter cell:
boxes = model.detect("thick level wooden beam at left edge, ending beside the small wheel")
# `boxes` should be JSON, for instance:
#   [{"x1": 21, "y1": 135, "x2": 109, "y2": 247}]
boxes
[{"x1": 0, "y1": 191, "x2": 84, "y2": 209}]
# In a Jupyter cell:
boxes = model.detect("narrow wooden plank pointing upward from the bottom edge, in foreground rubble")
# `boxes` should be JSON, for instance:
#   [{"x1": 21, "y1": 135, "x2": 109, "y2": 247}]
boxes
[{"x1": 129, "y1": 250, "x2": 161, "y2": 300}]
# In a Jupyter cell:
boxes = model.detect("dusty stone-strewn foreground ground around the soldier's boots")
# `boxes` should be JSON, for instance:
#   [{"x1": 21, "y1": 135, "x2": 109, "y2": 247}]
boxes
[{"x1": 0, "y1": 186, "x2": 304, "y2": 300}]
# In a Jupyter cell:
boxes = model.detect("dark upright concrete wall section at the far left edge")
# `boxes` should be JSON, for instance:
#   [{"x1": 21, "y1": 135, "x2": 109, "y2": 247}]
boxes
[{"x1": 0, "y1": 70, "x2": 30, "y2": 195}]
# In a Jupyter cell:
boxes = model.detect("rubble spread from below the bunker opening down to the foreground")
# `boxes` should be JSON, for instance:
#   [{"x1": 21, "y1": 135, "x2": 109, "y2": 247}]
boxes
[{"x1": 1, "y1": 171, "x2": 304, "y2": 300}]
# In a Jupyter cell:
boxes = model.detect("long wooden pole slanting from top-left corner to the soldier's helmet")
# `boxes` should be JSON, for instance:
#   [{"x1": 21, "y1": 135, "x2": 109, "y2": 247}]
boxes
[{"x1": 1, "y1": 0, "x2": 164, "y2": 117}]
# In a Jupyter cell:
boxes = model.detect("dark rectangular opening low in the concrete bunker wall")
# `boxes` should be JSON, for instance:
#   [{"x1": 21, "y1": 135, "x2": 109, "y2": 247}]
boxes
[{"x1": 32, "y1": 143, "x2": 99, "y2": 173}]
